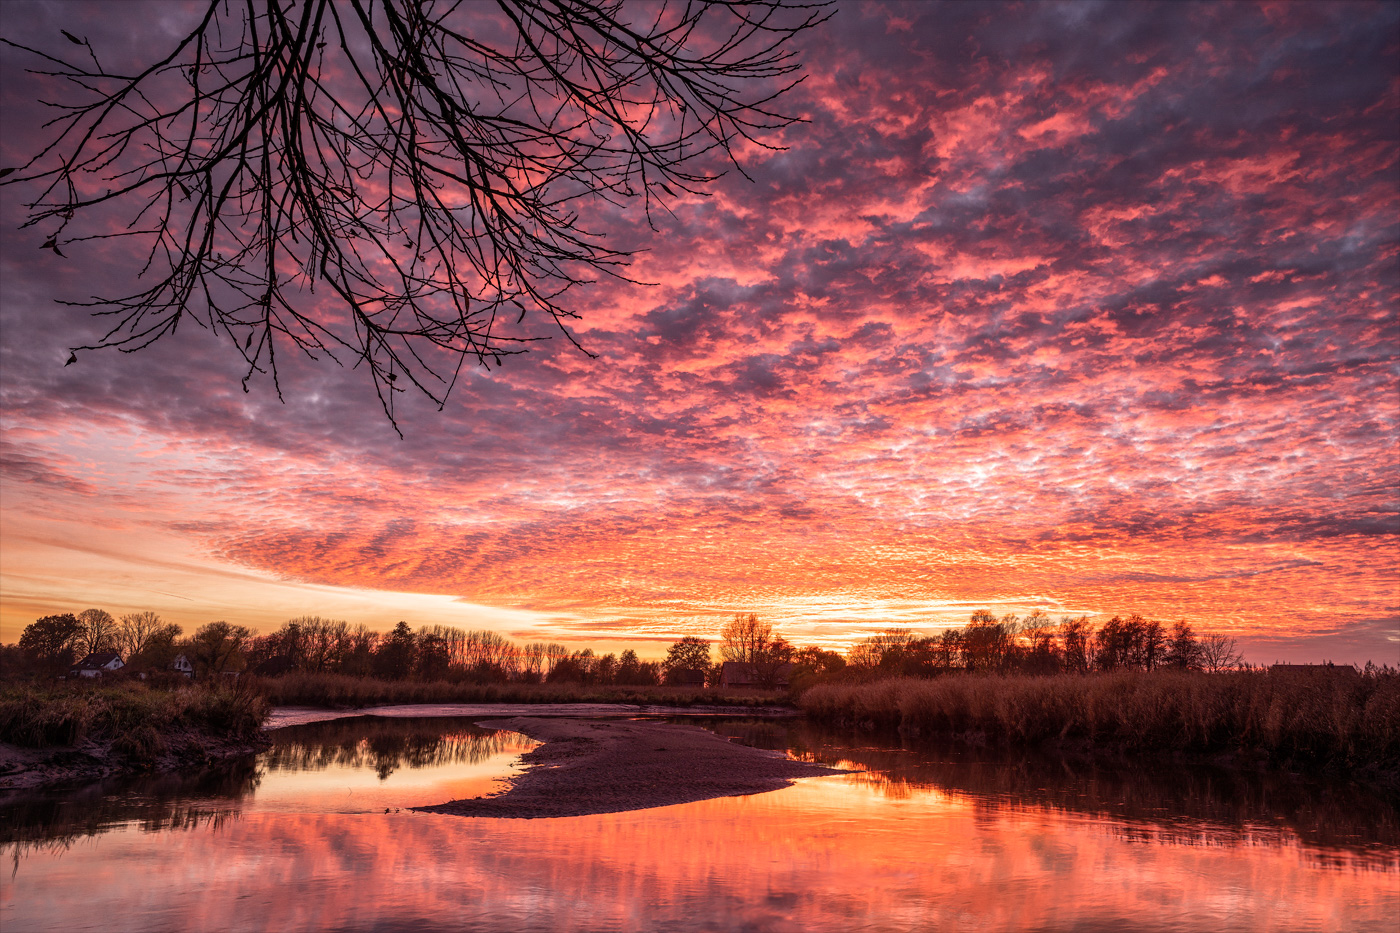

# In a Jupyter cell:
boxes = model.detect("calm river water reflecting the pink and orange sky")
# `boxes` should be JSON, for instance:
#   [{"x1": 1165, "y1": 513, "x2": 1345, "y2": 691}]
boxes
[{"x1": 0, "y1": 717, "x2": 1400, "y2": 933}]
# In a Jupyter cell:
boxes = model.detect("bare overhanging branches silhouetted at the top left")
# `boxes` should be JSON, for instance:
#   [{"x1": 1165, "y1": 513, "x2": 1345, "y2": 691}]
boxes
[{"x1": 0, "y1": 0, "x2": 830, "y2": 422}]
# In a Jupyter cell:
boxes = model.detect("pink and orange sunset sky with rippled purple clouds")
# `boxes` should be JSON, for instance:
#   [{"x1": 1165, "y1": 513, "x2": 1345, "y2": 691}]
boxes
[{"x1": 0, "y1": 0, "x2": 1400, "y2": 664}]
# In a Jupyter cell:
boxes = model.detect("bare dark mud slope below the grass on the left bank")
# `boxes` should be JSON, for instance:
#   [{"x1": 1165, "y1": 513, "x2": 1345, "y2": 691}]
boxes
[{"x1": 0, "y1": 731, "x2": 270, "y2": 794}]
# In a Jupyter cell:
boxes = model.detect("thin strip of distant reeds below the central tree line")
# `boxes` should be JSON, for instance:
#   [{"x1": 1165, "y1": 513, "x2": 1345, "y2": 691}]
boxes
[{"x1": 252, "y1": 674, "x2": 792, "y2": 707}]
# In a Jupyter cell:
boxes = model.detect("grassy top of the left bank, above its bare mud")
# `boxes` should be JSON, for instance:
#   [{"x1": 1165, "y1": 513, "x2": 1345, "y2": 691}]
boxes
[{"x1": 0, "y1": 682, "x2": 270, "y2": 770}]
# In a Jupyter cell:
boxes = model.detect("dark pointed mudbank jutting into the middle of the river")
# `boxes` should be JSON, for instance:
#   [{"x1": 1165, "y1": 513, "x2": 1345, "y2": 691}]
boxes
[{"x1": 419, "y1": 717, "x2": 846, "y2": 820}]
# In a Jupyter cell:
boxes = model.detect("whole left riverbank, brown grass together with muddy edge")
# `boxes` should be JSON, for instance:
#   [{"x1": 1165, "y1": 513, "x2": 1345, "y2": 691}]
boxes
[{"x1": 0, "y1": 682, "x2": 269, "y2": 792}]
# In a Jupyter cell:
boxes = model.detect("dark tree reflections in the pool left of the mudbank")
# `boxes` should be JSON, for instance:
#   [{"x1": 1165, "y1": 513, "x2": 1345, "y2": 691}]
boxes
[{"x1": 262, "y1": 716, "x2": 528, "y2": 780}]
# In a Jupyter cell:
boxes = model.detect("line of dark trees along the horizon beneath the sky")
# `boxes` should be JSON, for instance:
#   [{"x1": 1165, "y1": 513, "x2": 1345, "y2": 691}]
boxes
[{"x1": 4, "y1": 609, "x2": 1240, "y2": 688}]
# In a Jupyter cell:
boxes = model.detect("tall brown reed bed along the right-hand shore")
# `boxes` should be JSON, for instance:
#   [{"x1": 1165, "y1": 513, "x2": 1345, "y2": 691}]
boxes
[{"x1": 799, "y1": 671, "x2": 1400, "y2": 778}]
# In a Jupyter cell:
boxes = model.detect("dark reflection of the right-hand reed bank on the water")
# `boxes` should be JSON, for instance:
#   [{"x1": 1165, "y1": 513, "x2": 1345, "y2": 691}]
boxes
[{"x1": 689, "y1": 720, "x2": 1400, "y2": 870}]
